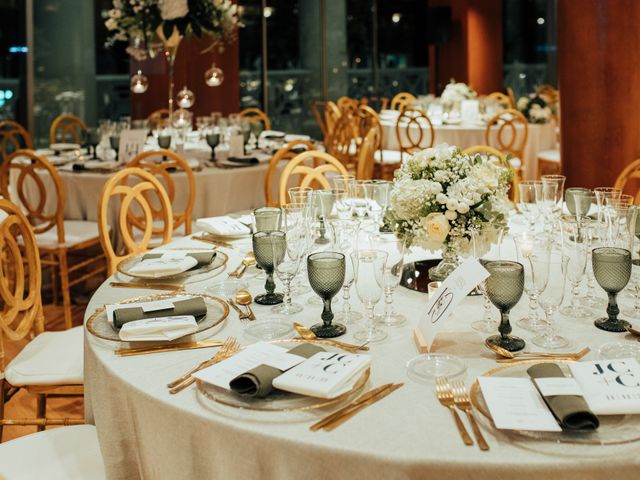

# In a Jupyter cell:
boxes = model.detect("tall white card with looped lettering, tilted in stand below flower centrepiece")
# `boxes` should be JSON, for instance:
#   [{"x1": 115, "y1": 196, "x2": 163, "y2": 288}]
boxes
[{"x1": 418, "y1": 258, "x2": 489, "y2": 350}]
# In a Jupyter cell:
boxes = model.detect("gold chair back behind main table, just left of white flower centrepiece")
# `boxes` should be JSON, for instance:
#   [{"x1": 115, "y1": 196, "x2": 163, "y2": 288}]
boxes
[{"x1": 278, "y1": 150, "x2": 348, "y2": 205}]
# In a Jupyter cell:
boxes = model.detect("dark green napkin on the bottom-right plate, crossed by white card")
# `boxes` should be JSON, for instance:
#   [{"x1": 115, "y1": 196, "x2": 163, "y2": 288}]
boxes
[{"x1": 527, "y1": 363, "x2": 600, "y2": 430}]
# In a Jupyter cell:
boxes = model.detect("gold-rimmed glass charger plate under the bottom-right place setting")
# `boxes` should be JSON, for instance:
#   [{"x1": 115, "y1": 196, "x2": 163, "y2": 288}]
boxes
[{"x1": 470, "y1": 359, "x2": 640, "y2": 448}]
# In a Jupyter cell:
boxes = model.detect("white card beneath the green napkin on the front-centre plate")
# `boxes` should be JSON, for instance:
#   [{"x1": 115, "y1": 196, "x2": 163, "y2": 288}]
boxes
[{"x1": 192, "y1": 342, "x2": 305, "y2": 390}]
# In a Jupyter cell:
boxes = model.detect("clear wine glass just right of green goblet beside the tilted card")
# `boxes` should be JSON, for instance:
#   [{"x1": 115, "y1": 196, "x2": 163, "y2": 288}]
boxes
[{"x1": 531, "y1": 252, "x2": 569, "y2": 348}]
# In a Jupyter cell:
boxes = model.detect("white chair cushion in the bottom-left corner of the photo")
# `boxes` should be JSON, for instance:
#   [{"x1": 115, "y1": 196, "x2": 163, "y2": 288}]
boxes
[{"x1": 0, "y1": 425, "x2": 106, "y2": 480}]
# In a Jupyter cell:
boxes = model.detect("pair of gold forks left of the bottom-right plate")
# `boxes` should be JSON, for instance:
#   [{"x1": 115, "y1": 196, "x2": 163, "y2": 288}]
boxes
[{"x1": 436, "y1": 377, "x2": 489, "y2": 451}]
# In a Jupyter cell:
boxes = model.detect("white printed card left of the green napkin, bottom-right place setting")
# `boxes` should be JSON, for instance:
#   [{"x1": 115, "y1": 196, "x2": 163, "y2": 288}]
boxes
[{"x1": 478, "y1": 377, "x2": 562, "y2": 432}]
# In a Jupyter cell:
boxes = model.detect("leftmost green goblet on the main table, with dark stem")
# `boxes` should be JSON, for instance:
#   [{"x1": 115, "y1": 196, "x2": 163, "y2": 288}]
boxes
[{"x1": 251, "y1": 231, "x2": 287, "y2": 305}]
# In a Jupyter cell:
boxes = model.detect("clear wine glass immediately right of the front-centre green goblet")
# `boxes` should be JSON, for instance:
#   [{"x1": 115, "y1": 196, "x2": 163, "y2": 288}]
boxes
[{"x1": 372, "y1": 233, "x2": 407, "y2": 326}]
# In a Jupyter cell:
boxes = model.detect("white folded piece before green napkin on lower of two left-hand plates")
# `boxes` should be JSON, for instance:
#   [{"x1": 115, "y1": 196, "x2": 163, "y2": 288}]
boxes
[{"x1": 118, "y1": 315, "x2": 198, "y2": 342}]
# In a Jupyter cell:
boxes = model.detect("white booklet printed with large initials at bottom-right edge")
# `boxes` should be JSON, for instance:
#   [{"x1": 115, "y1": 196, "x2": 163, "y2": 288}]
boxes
[{"x1": 569, "y1": 358, "x2": 640, "y2": 415}]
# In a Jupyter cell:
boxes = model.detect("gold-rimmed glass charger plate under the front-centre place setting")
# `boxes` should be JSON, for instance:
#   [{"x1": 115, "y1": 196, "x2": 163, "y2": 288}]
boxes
[{"x1": 196, "y1": 338, "x2": 371, "y2": 413}]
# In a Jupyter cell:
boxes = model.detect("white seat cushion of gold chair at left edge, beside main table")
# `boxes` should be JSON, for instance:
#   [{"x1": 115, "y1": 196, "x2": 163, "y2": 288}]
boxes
[{"x1": 4, "y1": 327, "x2": 84, "y2": 387}]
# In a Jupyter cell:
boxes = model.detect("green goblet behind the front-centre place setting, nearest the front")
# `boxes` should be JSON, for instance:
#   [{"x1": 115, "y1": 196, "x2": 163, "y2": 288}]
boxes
[{"x1": 307, "y1": 252, "x2": 347, "y2": 338}]
